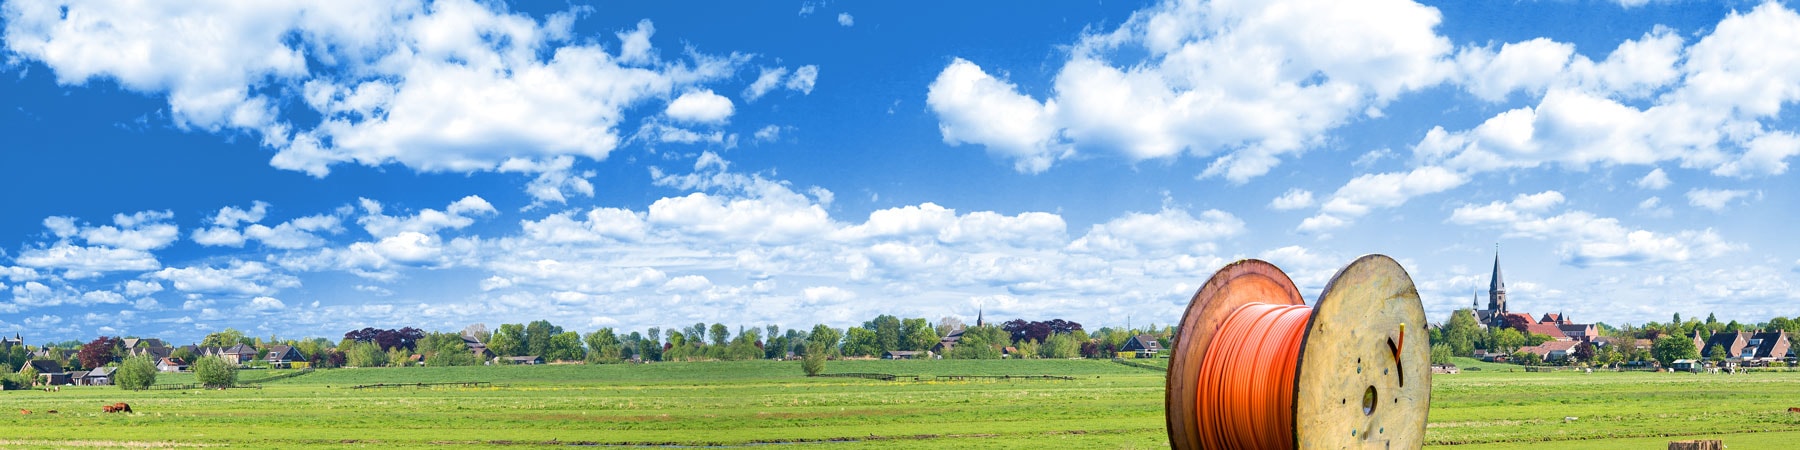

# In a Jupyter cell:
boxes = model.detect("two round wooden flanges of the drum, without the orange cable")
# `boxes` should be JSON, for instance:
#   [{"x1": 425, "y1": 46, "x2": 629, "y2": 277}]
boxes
[{"x1": 1163, "y1": 254, "x2": 1431, "y2": 450}]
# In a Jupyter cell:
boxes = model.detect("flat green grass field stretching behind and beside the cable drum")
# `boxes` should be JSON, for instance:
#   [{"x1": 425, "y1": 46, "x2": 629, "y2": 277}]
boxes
[{"x1": 0, "y1": 360, "x2": 1800, "y2": 448}]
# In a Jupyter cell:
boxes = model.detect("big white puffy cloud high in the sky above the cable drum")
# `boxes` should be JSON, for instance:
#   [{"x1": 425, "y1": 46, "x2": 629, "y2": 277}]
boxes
[{"x1": 929, "y1": 0, "x2": 1451, "y2": 182}]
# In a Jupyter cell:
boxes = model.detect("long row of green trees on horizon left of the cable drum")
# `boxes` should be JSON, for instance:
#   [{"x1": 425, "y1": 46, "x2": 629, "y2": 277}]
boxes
[{"x1": 14, "y1": 315, "x2": 1174, "y2": 376}]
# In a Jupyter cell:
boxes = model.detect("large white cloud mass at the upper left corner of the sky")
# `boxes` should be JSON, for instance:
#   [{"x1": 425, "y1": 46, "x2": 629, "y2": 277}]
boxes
[{"x1": 0, "y1": 0, "x2": 774, "y2": 191}]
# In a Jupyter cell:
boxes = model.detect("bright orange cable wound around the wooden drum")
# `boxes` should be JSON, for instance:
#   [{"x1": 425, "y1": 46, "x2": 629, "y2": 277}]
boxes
[{"x1": 1195, "y1": 302, "x2": 1312, "y2": 448}]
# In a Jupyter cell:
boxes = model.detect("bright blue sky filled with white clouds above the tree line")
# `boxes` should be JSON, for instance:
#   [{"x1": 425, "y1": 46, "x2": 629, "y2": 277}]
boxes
[{"x1": 0, "y1": 0, "x2": 1800, "y2": 342}]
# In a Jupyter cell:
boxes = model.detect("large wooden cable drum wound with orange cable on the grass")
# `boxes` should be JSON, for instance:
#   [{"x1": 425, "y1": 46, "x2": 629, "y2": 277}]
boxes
[{"x1": 1163, "y1": 254, "x2": 1431, "y2": 450}]
